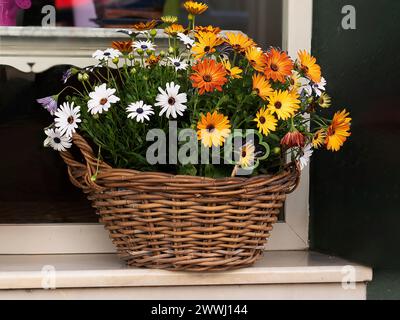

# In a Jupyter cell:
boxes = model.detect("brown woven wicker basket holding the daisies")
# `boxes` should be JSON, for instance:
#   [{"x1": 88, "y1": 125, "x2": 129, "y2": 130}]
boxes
[{"x1": 61, "y1": 134, "x2": 300, "y2": 271}]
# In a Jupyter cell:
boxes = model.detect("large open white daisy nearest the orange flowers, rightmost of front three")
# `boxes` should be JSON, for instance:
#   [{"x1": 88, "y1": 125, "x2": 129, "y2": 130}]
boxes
[{"x1": 155, "y1": 82, "x2": 187, "y2": 118}]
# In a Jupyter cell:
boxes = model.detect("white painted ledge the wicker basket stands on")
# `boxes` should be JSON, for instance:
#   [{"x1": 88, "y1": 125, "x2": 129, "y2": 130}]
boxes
[{"x1": 0, "y1": 251, "x2": 372, "y2": 299}]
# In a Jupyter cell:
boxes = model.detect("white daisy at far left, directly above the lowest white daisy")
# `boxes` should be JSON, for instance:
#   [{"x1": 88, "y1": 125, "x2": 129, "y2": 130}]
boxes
[{"x1": 54, "y1": 102, "x2": 81, "y2": 137}]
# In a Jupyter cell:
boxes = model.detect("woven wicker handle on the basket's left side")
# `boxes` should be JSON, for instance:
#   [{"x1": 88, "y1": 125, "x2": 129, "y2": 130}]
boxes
[{"x1": 60, "y1": 133, "x2": 111, "y2": 191}]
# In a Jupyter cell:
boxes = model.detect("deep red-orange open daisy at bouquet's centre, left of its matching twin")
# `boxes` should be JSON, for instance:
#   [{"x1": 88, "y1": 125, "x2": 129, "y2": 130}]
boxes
[{"x1": 190, "y1": 59, "x2": 228, "y2": 94}]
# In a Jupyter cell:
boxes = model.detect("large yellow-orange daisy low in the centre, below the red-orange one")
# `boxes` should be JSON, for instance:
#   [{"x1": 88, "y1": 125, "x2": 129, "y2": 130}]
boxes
[{"x1": 197, "y1": 111, "x2": 231, "y2": 148}]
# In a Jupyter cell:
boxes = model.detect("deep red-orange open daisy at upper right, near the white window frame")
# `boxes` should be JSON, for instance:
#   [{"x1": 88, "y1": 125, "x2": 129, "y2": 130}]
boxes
[{"x1": 264, "y1": 48, "x2": 293, "y2": 83}]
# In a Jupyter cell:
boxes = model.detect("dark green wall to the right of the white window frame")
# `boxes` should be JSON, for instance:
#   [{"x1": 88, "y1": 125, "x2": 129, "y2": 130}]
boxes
[{"x1": 310, "y1": 0, "x2": 400, "y2": 268}]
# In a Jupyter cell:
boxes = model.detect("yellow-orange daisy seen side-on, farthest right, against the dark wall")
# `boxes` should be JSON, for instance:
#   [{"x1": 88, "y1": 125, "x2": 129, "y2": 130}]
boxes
[{"x1": 325, "y1": 109, "x2": 351, "y2": 151}]
